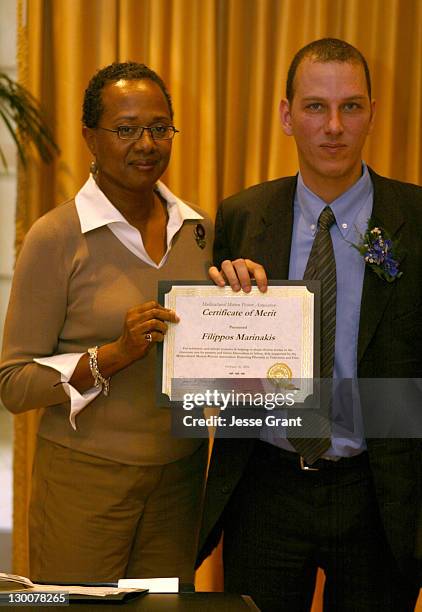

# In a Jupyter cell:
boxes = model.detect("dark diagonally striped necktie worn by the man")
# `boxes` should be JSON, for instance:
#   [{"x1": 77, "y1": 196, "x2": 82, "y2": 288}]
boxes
[{"x1": 289, "y1": 206, "x2": 336, "y2": 464}]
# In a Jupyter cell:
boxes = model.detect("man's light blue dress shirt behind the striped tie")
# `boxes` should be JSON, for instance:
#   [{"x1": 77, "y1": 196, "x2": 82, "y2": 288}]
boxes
[{"x1": 261, "y1": 163, "x2": 374, "y2": 457}]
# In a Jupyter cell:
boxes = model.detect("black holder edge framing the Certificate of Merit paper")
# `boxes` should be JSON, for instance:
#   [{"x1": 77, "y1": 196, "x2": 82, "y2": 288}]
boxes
[{"x1": 155, "y1": 280, "x2": 321, "y2": 408}]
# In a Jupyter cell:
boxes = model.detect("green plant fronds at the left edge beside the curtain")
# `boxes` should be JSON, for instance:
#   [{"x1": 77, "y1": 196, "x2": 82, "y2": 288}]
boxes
[{"x1": 0, "y1": 72, "x2": 59, "y2": 169}]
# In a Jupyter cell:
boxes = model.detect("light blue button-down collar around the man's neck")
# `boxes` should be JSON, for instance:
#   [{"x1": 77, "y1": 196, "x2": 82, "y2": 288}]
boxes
[{"x1": 296, "y1": 162, "x2": 373, "y2": 238}]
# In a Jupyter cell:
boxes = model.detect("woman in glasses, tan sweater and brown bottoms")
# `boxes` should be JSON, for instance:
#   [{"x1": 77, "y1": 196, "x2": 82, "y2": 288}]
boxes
[{"x1": 0, "y1": 63, "x2": 212, "y2": 582}]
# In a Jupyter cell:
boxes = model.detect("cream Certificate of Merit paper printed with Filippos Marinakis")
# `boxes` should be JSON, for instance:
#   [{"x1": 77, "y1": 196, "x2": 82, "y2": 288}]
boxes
[{"x1": 159, "y1": 281, "x2": 319, "y2": 401}]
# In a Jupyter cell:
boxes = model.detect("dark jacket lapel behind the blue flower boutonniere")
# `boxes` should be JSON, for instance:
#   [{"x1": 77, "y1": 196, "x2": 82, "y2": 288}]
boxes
[{"x1": 358, "y1": 169, "x2": 405, "y2": 363}]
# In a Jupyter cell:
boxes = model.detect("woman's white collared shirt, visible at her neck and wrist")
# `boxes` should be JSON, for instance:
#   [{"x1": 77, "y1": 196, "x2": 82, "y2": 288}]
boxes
[{"x1": 34, "y1": 176, "x2": 203, "y2": 430}]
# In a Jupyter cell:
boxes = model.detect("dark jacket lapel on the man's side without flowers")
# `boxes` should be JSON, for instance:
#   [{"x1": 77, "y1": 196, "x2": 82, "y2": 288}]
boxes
[{"x1": 251, "y1": 177, "x2": 296, "y2": 279}]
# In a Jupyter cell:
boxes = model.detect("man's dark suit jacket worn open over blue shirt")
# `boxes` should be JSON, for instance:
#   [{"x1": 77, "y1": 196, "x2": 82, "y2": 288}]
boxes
[{"x1": 198, "y1": 171, "x2": 422, "y2": 579}]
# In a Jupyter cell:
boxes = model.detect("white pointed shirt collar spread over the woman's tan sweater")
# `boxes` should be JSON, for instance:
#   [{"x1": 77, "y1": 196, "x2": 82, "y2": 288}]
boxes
[{"x1": 75, "y1": 176, "x2": 203, "y2": 234}]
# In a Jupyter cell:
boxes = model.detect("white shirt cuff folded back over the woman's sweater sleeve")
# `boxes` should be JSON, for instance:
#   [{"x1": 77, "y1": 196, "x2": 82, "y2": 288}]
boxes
[{"x1": 34, "y1": 353, "x2": 101, "y2": 431}]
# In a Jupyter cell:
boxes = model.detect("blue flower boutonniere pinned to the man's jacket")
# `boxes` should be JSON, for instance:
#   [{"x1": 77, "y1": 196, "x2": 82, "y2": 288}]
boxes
[{"x1": 352, "y1": 219, "x2": 403, "y2": 283}]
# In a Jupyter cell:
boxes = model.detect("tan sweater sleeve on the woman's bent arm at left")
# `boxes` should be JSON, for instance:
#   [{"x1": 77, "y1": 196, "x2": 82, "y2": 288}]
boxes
[{"x1": 0, "y1": 215, "x2": 74, "y2": 413}]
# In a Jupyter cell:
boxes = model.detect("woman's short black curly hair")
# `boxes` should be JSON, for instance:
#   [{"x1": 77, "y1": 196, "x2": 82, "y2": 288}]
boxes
[{"x1": 82, "y1": 62, "x2": 173, "y2": 128}]
